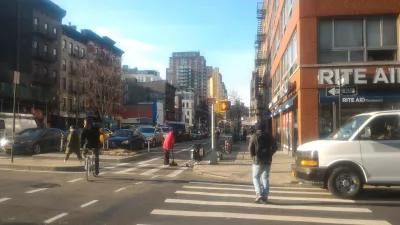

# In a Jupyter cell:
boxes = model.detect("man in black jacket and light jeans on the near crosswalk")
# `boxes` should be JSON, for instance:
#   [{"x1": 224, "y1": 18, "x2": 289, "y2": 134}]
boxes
[{"x1": 248, "y1": 122, "x2": 278, "y2": 204}]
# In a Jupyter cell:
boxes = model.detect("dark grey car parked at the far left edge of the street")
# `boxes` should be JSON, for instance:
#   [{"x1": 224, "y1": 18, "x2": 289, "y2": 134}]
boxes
[{"x1": 0, "y1": 128, "x2": 67, "y2": 154}]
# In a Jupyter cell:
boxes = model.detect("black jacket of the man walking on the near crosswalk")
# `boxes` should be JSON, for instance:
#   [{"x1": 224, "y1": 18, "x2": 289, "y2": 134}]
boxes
[{"x1": 248, "y1": 130, "x2": 278, "y2": 165}]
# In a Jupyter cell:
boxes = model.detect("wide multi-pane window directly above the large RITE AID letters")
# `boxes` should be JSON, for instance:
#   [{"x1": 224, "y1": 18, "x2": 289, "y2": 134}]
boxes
[{"x1": 318, "y1": 16, "x2": 397, "y2": 63}]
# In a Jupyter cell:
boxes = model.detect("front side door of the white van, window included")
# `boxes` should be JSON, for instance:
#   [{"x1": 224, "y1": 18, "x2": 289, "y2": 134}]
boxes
[{"x1": 359, "y1": 114, "x2": 400, "y2": 184}]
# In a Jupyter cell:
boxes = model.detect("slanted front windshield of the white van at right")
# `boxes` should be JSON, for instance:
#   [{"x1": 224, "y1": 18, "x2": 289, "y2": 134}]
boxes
[{"x1": 327, "y1": 115, "x2": 371, "y2": 141}]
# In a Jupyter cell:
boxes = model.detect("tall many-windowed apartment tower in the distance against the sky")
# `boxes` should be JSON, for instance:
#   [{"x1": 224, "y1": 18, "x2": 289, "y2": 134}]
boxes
[{"x1": 166, "y1": 52, "x2": 207, "y2": 102}]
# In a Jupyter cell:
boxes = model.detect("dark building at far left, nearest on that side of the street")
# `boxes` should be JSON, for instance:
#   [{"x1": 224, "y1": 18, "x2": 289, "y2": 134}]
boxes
[{"x1": 0, "y1": 0, "x2": 66, "y2": 126}]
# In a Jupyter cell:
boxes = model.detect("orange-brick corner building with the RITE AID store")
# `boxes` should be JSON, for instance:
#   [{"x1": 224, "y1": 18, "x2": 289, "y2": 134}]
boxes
[{"x1": 264, "y1": 0, "x2": 400, "y2": 154}]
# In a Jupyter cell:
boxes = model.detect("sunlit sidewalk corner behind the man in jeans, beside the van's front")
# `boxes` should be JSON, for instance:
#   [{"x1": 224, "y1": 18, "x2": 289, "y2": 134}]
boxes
[{"x1": 193, "y1": 140, "x2": 297, "y2": 185}]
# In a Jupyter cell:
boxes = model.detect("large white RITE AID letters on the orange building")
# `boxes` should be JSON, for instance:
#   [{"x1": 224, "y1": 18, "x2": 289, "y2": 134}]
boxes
[{"x1": 318, "y1": 68, "x2": 400, "y2": 85}]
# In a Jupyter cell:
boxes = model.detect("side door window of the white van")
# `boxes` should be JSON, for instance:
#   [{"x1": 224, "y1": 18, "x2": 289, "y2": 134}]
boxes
[{"x1": 360, "y1": 115, "x2": 400, "y2": 140}]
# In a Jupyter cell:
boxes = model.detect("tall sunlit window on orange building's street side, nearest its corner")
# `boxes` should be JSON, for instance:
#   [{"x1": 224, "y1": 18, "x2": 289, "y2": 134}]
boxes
[{"x1": 282, "y1": 31, "x2": 298, "y2": 80}]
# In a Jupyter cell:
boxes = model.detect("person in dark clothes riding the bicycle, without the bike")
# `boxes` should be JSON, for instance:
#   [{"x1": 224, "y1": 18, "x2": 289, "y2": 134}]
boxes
[{"x1": 81, "y1": 118, "x2": 100, "y2": 175}]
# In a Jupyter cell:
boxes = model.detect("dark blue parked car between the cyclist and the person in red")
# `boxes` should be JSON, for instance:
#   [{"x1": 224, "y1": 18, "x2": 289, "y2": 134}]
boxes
[{"x1": 108, "y1": 129, "x2": 145, "y2": 150}]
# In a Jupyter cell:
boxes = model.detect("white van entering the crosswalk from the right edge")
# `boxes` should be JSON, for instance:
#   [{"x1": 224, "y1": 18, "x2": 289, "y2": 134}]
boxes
[{"x1": 292, "y1": 110, "x2": 400, "y2": 198}]
